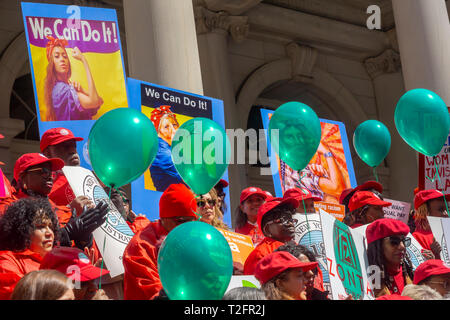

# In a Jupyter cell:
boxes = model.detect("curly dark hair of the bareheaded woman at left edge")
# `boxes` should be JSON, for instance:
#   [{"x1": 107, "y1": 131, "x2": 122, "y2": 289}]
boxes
[{"x1": 0, "y1": 197, "x2": 59, "y2": 251}]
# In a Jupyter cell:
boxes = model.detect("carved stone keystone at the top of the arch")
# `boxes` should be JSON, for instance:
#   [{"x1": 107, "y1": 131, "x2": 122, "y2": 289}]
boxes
[{"x1": 286, "y1": 42, "x2": 318, "y2": 83}]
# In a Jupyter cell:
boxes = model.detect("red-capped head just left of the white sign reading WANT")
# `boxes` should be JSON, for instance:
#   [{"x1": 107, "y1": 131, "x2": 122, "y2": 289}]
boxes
[{"x1": 347, "y1": 191, "x2": 392, "y2": 228}]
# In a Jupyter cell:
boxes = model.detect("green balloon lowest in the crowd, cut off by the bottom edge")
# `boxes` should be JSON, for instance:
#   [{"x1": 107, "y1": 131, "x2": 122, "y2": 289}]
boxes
[{"x1": 158, "y1": 221, "x2": 233, "y2": 300}]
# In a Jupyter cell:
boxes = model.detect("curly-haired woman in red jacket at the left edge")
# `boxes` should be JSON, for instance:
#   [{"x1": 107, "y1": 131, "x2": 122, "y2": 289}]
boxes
[{"x1": 0, "y1": 198, "x2": 59, "y2": 300}]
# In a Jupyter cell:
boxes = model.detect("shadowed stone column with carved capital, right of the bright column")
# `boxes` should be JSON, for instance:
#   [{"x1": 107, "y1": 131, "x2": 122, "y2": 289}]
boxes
[{"x1": 195, "y1": 6, "x2": 249, "y2": 220}]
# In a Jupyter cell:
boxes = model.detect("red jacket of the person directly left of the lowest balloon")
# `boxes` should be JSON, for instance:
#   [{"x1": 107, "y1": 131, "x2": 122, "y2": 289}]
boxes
[{"x1": 123, "y1": 220, "x2": 167, "y2": 300}]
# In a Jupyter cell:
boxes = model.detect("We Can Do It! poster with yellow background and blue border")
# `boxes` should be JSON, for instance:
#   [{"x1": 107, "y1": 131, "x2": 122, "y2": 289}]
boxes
[{"x1": 21, "y1": 2, "x2": 128, "y2": 168}]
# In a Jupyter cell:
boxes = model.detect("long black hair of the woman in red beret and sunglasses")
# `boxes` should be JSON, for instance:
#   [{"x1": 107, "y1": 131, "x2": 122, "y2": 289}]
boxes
[{"x1": 367, "y1": 239, "x2": 414, "y2": 288}]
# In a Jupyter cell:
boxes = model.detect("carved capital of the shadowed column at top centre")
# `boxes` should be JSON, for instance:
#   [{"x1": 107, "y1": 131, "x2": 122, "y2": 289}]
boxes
[{"x1": 194, "y1": 6, "x2": 250, "y2": 42}]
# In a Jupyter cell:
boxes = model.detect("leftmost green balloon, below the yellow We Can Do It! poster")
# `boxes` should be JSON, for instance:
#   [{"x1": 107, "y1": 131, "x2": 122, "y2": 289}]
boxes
[{"x1": 88, "y1": 108, "x2": 158, "y2": 188}]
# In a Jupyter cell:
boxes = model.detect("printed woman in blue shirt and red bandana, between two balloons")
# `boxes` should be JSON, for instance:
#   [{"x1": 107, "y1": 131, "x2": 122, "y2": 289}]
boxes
[{"x1": 150, "y1": 106, "x2": 184, "y2": 192}]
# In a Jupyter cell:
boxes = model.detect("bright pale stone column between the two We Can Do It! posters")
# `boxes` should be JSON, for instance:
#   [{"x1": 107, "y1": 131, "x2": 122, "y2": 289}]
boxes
[{"x1": 123, "y1": 0, "x2": 203, "y2": 95}]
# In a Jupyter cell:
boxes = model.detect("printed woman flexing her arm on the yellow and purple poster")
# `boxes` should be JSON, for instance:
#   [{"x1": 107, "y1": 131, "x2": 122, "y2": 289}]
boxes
[{"x1": 45, "y1": 36, "x2": 103, "y2": 121}]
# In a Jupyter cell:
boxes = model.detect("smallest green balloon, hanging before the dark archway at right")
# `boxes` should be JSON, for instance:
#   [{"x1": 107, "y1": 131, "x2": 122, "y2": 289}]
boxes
[{"x1": 353, "y1": 120, "x2": 391, "y2": 167}]
